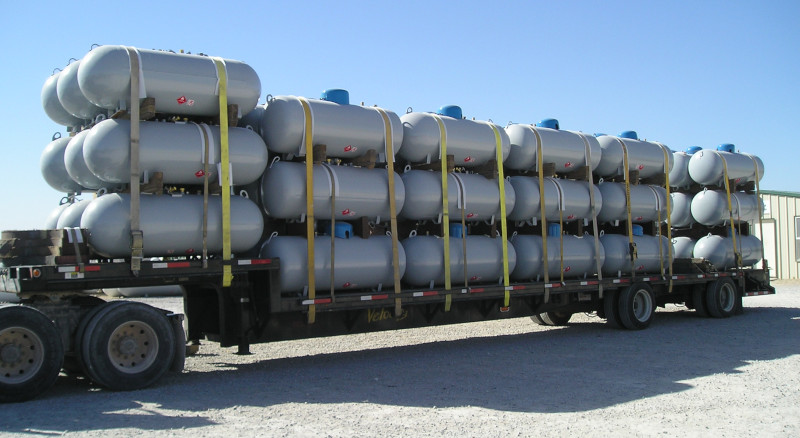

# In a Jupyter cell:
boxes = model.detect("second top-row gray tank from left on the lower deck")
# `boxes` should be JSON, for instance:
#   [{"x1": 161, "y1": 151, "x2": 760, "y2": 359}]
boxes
[{"x1": 397, "y1": 106, "x2": 511, "y2": 167}]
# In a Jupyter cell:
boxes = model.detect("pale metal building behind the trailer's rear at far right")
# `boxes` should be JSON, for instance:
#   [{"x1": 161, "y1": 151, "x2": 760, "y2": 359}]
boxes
[{"x1": 751, "y1": 190, "x2": 800, "y2": 279}]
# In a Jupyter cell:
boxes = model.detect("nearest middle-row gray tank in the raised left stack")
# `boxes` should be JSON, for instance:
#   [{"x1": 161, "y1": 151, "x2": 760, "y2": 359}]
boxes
[{"x1": 83, "y1": 119, "x2": 268, "y2": 185}]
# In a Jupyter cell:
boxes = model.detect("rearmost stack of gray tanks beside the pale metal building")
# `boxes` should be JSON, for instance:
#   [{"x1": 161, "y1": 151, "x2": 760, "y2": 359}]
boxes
[{"x1": 669, "y1": 143, "x2": 764, "y2": 270}]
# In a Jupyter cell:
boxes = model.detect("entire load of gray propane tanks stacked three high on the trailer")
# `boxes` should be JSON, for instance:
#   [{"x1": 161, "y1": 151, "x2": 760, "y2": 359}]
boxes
[{"x1": 41, "y1": 46, "x2": 763, "y2": 293}]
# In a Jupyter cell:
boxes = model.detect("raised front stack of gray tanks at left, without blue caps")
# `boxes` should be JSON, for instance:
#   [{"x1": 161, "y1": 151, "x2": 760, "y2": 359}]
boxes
[{"x1": 40, "y1": 46, "x2": 268, "y2": 258}]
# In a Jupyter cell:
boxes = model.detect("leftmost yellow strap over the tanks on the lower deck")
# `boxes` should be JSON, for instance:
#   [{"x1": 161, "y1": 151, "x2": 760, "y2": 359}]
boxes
[{"x1": 298, "y1": 97, "x2": 318, "y2": 324}]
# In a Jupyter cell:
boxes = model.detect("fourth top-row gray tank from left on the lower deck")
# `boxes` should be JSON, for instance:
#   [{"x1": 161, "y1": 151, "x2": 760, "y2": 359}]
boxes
[{"x1": 595, "y1": 131, "x2": 673, "y2": 178}]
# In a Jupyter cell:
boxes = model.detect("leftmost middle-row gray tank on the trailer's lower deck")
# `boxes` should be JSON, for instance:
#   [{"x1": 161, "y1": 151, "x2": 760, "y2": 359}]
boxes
[{"x1": 261, "y1": 161, "x2": 406, "y2": 220}]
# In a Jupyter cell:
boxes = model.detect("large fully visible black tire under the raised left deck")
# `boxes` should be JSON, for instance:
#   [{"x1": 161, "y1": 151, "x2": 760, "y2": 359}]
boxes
[{"x1": 80, "y1": 301, "x2": 175, "y2": 391}]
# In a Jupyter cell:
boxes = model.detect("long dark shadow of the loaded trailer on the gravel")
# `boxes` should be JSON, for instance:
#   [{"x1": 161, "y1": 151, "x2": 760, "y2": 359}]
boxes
[{"x1": 0, "y1": 307, "x2": 800, "y2": 433}]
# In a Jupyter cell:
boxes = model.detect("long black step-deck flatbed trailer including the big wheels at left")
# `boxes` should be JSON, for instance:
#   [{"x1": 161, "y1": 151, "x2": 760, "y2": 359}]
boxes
[{"x1": 0, "y1": 252, "x2": 775, "y2": 401}]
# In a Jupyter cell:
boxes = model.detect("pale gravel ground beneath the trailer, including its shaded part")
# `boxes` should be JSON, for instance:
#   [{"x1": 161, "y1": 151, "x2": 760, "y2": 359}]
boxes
[{"x1": 0, "y1": 282, "x2": 800, "y2": 437}]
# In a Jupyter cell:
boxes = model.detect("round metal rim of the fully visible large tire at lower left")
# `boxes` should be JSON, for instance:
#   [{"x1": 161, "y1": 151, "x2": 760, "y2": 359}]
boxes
[{"x1": 108, "y1": 321, "x2": 158, "y2": 374}]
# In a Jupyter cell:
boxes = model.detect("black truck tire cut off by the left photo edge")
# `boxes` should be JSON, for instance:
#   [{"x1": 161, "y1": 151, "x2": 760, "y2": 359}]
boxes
[{"x1": 0, "y1": 305, "x2": 64, "y2": 402}]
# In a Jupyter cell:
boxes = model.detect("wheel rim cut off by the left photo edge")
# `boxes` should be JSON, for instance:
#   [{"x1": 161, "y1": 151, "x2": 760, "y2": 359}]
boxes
[{"x1": 0, "y1": 327, "x2": 44, "y2": 384}]
